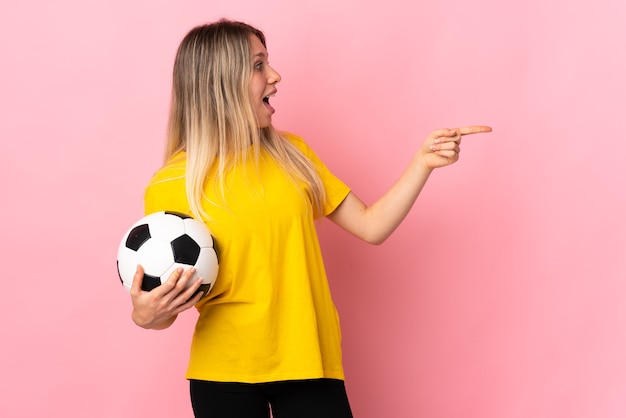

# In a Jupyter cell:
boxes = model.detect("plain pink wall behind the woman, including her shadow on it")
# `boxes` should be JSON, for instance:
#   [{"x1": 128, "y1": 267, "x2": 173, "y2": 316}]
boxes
[{"x1": 0, "y1": 0, "x2": 626, "y2": 418}]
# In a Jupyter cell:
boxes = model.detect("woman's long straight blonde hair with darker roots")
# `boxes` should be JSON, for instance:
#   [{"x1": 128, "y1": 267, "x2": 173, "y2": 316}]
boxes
[{"x1": 165, "y1": 20, "x2": 325, "y2": 219}]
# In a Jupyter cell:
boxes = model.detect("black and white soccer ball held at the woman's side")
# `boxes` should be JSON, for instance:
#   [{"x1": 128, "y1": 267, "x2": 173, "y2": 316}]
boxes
[{"x1": 117, "y1": 212, "x2": 219, "y2": 297}]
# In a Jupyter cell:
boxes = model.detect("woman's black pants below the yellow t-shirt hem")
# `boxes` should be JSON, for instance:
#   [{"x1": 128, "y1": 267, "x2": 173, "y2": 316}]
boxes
[{"x1": 189, "y1": 379, "x2": 352, "y2": 418}]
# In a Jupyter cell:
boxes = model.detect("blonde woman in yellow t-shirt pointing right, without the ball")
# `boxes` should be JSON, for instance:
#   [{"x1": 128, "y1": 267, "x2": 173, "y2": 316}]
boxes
[{"x1": 131, "y1": 20, "x2": 491, "y2": 418}]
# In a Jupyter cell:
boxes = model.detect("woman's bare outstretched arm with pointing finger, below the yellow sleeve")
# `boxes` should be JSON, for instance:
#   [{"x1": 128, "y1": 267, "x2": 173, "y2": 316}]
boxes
[{"x1": 328, "y1": 126, "x2": 491, "y2": 244}]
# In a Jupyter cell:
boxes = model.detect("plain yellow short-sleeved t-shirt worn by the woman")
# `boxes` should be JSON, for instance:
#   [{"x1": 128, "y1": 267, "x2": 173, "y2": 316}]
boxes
[{"x1": 145, "y1": 134, "x2": 350, "y2": 383}]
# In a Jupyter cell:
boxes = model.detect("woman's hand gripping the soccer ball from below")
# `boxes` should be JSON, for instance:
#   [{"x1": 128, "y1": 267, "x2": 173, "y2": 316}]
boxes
[{"x1": 130, "y1": 266, "x2": 202, "y2": 329}]
